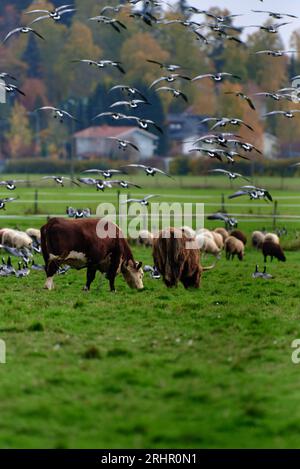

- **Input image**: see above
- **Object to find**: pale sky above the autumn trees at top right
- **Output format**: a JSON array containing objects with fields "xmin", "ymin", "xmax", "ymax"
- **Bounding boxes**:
[{"xmin": 167, "ymin": 0, "xmax": 300, "ymax": 47}]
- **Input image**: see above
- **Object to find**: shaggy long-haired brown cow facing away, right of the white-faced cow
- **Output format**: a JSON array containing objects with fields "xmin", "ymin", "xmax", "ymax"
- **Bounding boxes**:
[{"xmin": 153, "ymin": 228, "xmax": 214, "ymax": 288}]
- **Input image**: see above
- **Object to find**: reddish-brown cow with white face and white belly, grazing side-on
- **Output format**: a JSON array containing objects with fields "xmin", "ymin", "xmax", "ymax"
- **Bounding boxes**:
[{"xmin": 41, "ymin": 218, "xmax": 144, "ymax": 291}]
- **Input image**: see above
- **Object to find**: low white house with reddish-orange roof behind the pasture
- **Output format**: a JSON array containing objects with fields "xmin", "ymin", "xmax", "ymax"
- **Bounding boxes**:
[{"xmin": 74, "ymin": 125, "xmax": 159, "ymax": 160}]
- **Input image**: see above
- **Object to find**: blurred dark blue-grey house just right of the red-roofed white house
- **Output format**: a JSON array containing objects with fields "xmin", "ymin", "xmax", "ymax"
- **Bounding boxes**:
[{"xmin": 167, "ymin": 112, "xmax": 208, "ymax": 156}]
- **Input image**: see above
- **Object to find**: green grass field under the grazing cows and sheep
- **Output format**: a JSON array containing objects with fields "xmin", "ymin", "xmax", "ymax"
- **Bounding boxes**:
[{"xmin": 0, "ymin": 177, "xmax": 300, "ymax": 448}]
